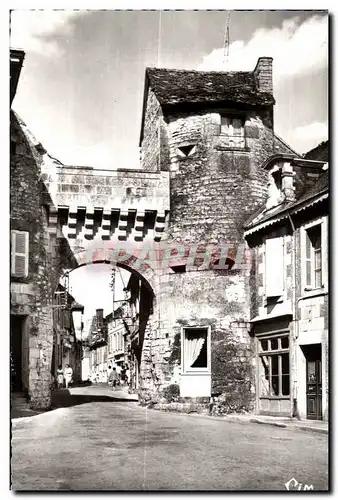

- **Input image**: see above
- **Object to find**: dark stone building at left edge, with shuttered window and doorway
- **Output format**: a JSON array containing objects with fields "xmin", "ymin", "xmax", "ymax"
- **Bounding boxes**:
[{"xmin": 10, "ymin": 50, "xmax": 74, "ymax": 409}]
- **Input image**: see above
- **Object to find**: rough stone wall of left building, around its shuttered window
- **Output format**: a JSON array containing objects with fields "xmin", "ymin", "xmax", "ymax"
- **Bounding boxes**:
[{"xmin": 10, "ymin": 113, "xmax": 74, "ymax": 409}]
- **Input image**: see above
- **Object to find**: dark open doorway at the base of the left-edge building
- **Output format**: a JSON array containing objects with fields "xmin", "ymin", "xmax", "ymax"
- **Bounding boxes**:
[{"xmin": 10, "ymin": 314, "xmax": 25, "ymax": 392}]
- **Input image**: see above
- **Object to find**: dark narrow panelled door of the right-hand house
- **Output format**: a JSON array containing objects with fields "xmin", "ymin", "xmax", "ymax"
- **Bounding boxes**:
[{"xmin": 306, "ymin": 344, "xmax": 323, "ymax": 420}]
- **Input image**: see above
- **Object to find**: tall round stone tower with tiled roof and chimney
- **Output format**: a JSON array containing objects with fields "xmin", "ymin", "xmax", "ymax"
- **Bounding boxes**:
[{"xmin": 140, "ymin": 57, "xmax": 294, "ymax": 408}]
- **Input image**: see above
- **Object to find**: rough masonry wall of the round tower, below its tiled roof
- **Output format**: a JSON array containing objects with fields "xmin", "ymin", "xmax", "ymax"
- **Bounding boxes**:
[{"xmin": 137, "ymin": 93, "xmax": 273, "ymax": 412}]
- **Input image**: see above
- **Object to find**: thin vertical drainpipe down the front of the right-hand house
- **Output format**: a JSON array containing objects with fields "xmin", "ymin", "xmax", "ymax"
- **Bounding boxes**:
[{"xmin": 287, "ymin": 212, "xmax": 300, "ymax": 420}]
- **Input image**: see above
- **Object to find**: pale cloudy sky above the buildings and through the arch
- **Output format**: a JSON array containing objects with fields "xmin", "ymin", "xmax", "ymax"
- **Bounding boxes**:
[{"xmin": 11, "ymin": 10, "xmax": 328, "ymax": 324}]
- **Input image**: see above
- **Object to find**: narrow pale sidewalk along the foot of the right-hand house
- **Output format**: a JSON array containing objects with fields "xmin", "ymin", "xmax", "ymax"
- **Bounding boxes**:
[{"xmin": 223, "ymin": 415, "xmax": 329, "ymax": 434}]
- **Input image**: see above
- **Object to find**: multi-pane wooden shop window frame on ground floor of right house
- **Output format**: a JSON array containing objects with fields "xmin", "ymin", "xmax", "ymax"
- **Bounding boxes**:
[{"xmin": 256, "ymin": 330, "xmax": 292, "ymax": 399}]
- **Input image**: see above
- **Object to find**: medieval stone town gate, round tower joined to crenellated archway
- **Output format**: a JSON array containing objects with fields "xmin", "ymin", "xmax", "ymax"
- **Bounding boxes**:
[{"xmin": 36, "ymin": 58, "xmax": 284, "ymax": 408}]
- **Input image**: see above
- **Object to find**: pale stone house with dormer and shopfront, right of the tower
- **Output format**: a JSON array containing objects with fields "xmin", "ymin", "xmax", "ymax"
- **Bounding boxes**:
[{"xmin": 245, "ymin": 143, "xmax": 329, "ymax": 420}]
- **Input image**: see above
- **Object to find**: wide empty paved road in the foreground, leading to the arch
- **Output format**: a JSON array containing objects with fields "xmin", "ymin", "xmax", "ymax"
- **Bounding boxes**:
[{"xmin": 12, "ymin": 387, "xmax": 328, "ymax": 491}]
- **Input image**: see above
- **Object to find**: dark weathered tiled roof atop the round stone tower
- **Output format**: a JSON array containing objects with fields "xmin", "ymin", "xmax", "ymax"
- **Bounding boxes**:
[{"xmin": 146, "ymin": 68, "xmax": 275, "ymax": 105}]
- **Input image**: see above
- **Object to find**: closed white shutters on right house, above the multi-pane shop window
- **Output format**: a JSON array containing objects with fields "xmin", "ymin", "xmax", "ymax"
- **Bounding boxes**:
[{"xmin": 265, "ymin": 237, "xmax": 284, "ymax": 297}]
